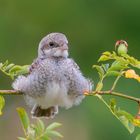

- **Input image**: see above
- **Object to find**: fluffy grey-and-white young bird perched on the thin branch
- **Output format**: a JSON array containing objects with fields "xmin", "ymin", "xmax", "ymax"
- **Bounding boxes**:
[{"xmin": 12, "ymin": 33, "xmax": 92, "ymax": 118}]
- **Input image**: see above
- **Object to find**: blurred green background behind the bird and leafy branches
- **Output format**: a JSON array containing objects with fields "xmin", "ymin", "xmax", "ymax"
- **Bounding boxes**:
[{"xmin": 0, "ymin": 0, "xmax": 140, "ymax": 140}]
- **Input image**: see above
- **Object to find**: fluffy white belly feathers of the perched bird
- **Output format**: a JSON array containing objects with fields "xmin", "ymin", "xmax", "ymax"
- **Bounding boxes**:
[{"xmin": 36, "ymin": 82, "xmax": 74, "ymax": 108}]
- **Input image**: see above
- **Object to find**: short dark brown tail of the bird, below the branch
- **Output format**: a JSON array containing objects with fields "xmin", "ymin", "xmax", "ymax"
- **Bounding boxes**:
[{"xmin": 31, "ymin": 105, "xmax": 58, "ymax": 119}]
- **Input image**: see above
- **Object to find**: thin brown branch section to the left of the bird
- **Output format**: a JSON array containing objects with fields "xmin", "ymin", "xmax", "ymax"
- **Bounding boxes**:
[{"xmin": 0, "ymin": 90, "xmax": 23, "ymax": 95}]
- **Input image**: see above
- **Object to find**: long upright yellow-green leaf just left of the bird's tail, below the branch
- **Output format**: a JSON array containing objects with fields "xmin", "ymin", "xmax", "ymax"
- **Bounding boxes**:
[{"xmin": 17, "ymin": 107, "xmax": 30, "ymax": 133}]
